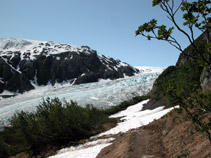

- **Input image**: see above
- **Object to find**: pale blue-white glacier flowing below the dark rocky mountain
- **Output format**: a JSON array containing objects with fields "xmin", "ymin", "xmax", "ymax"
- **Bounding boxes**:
[{"xmin": 0, "ymin": 67, "xmax": 164, "ymax": 128}]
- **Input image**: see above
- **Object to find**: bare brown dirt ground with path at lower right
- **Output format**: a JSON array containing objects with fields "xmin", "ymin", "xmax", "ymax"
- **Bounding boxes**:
[{"xmin": 97, "ymin": 112, "xmax": 211, "ymax": 158}]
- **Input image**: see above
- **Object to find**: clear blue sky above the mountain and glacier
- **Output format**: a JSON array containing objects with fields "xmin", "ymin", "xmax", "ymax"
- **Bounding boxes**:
[{"xmin": 0, "ymin": 0, "xmax": 201, "ymax": 67}]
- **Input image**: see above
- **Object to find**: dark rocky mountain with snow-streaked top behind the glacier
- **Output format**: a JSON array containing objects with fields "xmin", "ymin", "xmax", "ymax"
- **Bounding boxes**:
[{"xmin": 0, "ymin": 38, "xmax": 139, "ymax": 93}]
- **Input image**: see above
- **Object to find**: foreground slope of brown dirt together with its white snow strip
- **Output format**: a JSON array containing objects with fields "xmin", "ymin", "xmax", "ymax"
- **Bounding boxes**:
[{"xmin": 6, "ymin": 100, "xmax": 211, "ymax": 158}]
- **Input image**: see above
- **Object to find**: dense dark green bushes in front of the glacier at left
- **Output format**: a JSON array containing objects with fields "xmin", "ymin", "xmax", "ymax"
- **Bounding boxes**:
[{"xmin": 0, "ymin": 96, "xmax": 148, "ymax": 158}]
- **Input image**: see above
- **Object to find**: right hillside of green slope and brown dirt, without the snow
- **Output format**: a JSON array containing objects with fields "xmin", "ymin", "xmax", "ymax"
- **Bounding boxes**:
[{"xmin": 97, "ymin": 32, "xmax": 211, "ymax": 158}]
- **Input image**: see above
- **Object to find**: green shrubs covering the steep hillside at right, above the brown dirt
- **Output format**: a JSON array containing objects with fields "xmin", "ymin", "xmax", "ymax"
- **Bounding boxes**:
[{"xmin": 149, "ymin": 44, "xmax": 211, "ymax": 141}]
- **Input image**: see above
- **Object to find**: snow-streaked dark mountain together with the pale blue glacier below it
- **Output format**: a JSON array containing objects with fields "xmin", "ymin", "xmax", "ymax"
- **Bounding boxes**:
[{"xmin": 0, "ymin": 38, "xmax": 166, "ymax": 127}]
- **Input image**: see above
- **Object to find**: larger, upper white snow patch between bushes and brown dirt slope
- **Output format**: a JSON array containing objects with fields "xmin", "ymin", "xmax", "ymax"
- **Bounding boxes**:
[{"xmin": 94, "ymin": 100, "xmax": 178, "ymax": 138}]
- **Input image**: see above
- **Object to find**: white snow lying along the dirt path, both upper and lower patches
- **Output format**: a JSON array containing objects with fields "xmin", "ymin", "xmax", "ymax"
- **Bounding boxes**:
[{"xmin": 49, "ymin": 100, "xmax": 177, "ymax": 158}]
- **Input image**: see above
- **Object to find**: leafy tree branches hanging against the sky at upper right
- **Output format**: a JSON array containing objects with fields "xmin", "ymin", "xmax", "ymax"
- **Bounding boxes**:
[{"xmin": 136, "ymin": 0, "xmax": 211, "ymax": 67}]
